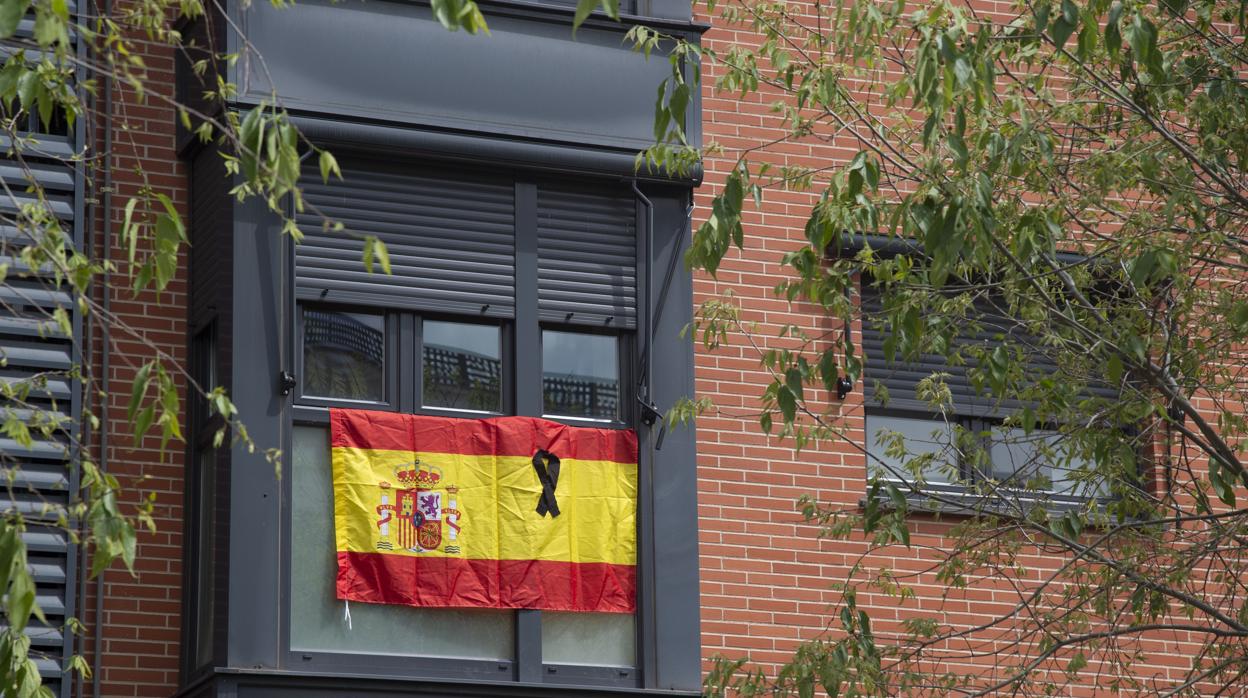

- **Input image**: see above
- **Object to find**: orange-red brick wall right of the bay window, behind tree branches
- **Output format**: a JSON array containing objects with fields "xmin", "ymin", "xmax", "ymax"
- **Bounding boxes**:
[{"xmin": 694, "ymin": 1, "xmax": 1213, "ymax": 694}]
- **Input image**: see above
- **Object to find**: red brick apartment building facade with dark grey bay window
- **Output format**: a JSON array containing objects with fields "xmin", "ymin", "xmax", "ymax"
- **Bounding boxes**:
[{"xmin": 0, "ymin": 0, "xmax": 1208, "ymax": 697}]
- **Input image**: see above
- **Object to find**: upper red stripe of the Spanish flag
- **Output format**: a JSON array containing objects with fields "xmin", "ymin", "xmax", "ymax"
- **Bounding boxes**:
[{"xmin": 329, "ymin": 410, "xmax": 636, "ymax": 463}]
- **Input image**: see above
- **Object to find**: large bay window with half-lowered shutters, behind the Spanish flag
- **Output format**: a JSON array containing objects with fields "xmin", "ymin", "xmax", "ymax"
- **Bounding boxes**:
[{"xmin": 286, "ymin": 157, "xmax": 639, "ymax": 686}]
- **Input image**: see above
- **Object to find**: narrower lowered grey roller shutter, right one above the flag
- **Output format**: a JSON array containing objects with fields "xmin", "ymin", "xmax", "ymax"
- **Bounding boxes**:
[{"xmin": 538, "ymin": 185, "xmax": 636, "ymax": 328}]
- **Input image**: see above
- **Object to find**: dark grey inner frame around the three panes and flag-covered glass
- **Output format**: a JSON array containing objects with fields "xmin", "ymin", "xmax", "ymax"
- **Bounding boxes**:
[{"xmin": 280, "ymin": 158, "xmax": 653, "ymax": 688}]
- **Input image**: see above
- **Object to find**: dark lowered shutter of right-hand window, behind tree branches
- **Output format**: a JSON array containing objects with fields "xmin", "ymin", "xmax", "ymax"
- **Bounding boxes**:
[{"xmin": 861, "ymin": 283, "xmax": 1118, "ymax": 418}]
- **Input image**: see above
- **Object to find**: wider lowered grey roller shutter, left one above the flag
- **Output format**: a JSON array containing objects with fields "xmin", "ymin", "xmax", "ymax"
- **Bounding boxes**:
[{"xmin": 295, "ymin": 161, "xmax": 515, "ymax": 317}]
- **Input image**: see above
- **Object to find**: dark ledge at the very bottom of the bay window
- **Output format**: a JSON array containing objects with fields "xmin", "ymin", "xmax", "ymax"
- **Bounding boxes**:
[{"xmin": 173, "ymin": 668, "xmax": 700, "ymax": 698}]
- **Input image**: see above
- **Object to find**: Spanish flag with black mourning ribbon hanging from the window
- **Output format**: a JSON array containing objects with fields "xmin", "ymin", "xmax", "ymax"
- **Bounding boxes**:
[{"xmin": 326, "ymin": 410, "xmax": 636, "ymax": 613}]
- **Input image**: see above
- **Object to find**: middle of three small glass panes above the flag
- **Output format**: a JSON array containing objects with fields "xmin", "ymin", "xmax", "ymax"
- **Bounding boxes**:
[{"xmin": 423, "ymin": 320, "xmax": 503, "ymax": 412}]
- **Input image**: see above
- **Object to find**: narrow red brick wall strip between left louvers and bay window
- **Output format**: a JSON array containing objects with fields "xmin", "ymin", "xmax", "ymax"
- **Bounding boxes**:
[{"xmin": 79, "ymin": 34, "xmax": 188, "ymax": 697}]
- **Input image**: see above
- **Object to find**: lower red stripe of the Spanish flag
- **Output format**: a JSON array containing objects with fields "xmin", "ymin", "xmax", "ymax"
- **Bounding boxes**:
[{"xmin": 337, "ymin": 552, "xmax": 636, "ymax": 613}]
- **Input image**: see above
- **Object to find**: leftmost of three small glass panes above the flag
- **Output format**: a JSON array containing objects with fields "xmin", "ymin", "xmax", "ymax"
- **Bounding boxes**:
[{"xmin": 303, "ymin": 308, "xmax": 386, "ymax": 402}]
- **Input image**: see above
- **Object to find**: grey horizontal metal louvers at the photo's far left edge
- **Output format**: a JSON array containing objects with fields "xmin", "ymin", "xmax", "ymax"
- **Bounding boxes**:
[{"xmin": 0, "ymin": 134, "xmax": 81, "ymax": 696}]
